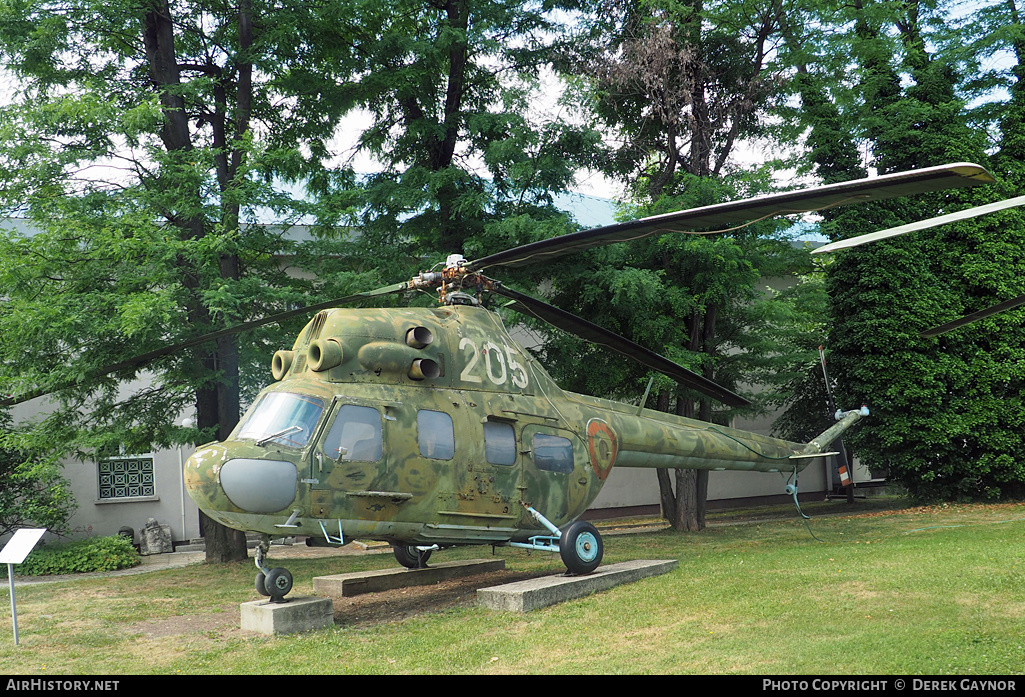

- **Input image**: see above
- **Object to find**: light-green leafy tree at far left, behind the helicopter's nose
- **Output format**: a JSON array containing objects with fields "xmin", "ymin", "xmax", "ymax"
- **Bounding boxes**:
[{"xmin": 0, "ymin": 0, "xmax": 373, "ymax": 561}]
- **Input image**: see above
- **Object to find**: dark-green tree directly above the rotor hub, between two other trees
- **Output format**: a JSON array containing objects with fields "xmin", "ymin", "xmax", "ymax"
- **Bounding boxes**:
[{"xmin": 311, "ymin": 0, "xmax": 599, "ymax": 262}]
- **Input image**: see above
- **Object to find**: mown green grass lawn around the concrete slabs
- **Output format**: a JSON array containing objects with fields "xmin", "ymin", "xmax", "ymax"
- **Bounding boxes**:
[{"xmin": 0, "ymin": 503, "xmax": 1025, "ymax": 675}]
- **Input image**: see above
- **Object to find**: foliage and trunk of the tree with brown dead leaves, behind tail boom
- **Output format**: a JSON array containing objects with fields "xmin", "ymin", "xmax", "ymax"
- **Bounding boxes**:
[{"xmin": 545, "ymin": 0, "xmax": 828, "ymax": 530}]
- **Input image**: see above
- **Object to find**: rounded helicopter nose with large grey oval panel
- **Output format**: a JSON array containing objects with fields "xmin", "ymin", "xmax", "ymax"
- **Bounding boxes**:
[{"xmin": 186, "ymin": 443, "xmax": 298, "ymax": 514}]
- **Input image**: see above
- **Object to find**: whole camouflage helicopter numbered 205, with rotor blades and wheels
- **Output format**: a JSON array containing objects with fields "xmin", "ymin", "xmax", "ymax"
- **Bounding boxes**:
[{"xmin": 172, "ymin": 158, "xmax": 994, "ymax": 602}]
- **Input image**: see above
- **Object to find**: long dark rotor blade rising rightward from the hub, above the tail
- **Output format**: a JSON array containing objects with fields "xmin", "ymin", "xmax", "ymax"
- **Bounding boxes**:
[{"xmin": 466, "ymin": 162, "xmax": 995, "ymax": 271}]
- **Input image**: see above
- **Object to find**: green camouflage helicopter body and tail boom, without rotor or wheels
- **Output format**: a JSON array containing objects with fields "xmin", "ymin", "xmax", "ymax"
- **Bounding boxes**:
[{"xmin": 186, "ymin": 305, "xmax": 831, "ymax": 546}]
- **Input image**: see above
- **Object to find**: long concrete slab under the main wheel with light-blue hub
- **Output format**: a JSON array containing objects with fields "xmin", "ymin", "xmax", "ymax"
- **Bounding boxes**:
[{"xmin": 477, "ymin": 559, "xmax": 679, "ymax": 612}]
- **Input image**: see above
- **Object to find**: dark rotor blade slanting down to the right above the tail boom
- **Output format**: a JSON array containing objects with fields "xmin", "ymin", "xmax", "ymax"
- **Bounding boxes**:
[{"xmin": 492, "ymin": 284, "xmax": 751, "ymax": 407}]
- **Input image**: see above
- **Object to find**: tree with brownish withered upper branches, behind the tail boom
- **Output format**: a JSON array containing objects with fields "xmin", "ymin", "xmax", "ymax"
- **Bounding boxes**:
[{"xmin": 561, "ymin": 0, "xmax": 807, "ymax": 530}]
